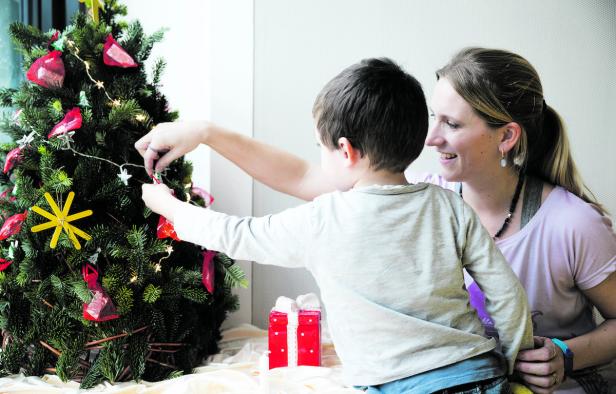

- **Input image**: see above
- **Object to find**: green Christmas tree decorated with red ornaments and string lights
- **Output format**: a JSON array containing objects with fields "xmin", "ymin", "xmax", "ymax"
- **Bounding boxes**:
[{"xmin": 0, "ymin": 0, "xmax": 246, "ymax": 388}]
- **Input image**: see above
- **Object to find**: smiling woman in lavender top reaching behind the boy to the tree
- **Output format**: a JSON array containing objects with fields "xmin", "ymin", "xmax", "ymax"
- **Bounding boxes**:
[{"xmin": 136, "ymin": 48, "xmax": 616, "ymax": 393}]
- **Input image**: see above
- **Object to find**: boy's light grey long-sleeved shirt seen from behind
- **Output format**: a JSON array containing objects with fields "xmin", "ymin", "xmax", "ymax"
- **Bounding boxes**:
[{"xmin": 174, "ymin": 183, "xmax": 533, "ymax": 386}]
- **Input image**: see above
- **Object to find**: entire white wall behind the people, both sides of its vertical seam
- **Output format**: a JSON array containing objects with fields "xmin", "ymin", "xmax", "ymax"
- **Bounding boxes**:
[{"xmin": 119, "ymin": 0, "xmax": 616, "ymax": 327}]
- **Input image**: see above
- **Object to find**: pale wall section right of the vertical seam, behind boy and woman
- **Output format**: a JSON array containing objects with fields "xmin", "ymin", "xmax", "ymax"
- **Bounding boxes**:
[{"xmin": 252, "ymin": 0, "xmax": 616, "ymax": 327}]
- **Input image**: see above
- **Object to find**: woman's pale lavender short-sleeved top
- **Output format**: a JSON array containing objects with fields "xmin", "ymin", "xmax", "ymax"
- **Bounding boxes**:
[{"xmin": 496, "ymin": 187, "xmax": 616, "ymax": 339}]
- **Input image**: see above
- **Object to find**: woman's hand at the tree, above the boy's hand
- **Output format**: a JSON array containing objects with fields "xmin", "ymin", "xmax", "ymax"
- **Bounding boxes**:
[{"xmin": 135, "ymin": 122, "xmax": 209, "ymax": 176}]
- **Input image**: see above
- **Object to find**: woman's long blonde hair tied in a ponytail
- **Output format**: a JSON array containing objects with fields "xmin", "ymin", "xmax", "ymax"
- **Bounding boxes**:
[{"xmin": 436, "ymin": 47, "xmax": 607, "ymax": 215}]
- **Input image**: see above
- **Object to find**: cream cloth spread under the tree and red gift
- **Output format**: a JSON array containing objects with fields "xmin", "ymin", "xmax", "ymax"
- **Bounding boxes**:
[{"xmin": 0, "ymin": 325, "xmax": 361, "ymax": 394}]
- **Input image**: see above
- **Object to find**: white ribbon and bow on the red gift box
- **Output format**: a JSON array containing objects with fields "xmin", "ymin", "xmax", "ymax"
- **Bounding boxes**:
[{"xmin": 273, "ymin": 293, "xmax": 321, "ymax": 367}]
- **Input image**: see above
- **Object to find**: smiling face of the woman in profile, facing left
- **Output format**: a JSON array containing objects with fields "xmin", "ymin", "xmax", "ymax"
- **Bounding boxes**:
[{"xmin": 426, "ymin": 78, "xmax": 501, "ymax": 182}]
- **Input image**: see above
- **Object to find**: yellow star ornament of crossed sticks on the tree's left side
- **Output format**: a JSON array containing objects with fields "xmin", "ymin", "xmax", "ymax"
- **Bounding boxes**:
[{"xmin": 30, "ymin": 192, "xmax": 92, "ymax": 250}]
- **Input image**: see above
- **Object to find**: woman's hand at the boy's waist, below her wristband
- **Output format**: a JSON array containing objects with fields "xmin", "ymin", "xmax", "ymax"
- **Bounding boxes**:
[{"xmin": 515, "ymin": 337, "xmax": 565, "ymax": 394}]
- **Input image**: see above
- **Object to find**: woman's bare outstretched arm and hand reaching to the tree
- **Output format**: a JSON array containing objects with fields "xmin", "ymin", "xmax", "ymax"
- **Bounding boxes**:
[{"xmin": 135, "ymin": 122, "xmax": 335, "ymax": 201}]
